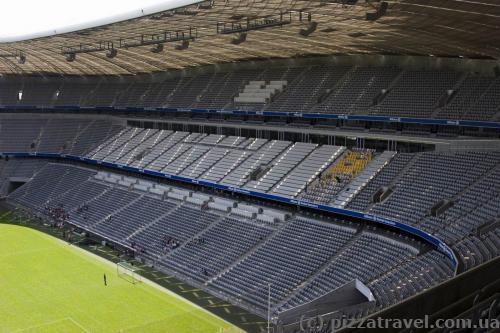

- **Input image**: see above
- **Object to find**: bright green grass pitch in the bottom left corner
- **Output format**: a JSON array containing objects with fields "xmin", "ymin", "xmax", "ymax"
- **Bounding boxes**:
[{"xmin": 0, "ymin": 220, "xmax": 243, "ymax": 333}]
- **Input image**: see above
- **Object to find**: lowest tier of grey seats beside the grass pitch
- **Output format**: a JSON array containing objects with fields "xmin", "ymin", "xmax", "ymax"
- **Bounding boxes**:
[{"xmin": 4, "ymin": 160, "xmax": 452, "ymax": 314}]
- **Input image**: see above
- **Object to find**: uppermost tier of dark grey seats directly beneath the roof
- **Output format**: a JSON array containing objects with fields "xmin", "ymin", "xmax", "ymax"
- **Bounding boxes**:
[{"xmin": 0, "ymin": 64, "xmax": 500, "ymax": 121}]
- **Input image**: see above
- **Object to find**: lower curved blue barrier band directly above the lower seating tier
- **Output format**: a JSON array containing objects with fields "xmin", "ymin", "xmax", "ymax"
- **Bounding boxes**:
[{"xmin": 0, "ymin": 152, "xmax": 458, "ymax": 272}]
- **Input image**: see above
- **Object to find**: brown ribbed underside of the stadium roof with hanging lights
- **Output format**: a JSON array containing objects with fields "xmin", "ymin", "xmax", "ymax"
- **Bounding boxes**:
[{"xmin": 0, "ymin": 0, "xmax": 500, "ymax": 75}]
